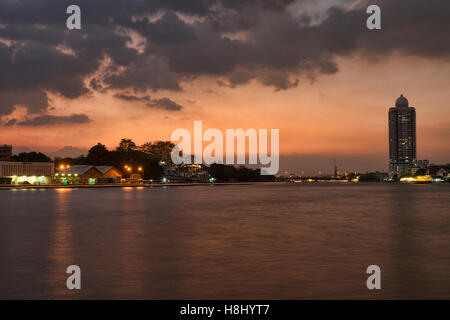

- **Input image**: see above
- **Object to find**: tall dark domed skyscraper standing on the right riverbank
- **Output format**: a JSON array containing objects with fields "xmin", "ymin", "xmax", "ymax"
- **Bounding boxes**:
[{"xmin": 389, "ymin": 95, "xmax": 417, "ymax": 178}]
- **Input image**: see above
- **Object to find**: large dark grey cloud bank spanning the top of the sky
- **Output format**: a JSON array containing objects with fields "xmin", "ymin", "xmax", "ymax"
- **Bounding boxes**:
[{"xmin": 0, "ymin": 0, "xmax": 450, "ymax": 115}]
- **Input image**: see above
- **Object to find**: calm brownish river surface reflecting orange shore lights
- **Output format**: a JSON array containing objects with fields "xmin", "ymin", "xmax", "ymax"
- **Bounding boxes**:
[{"xmin": 0, "ymin": 183, "xmax": 450, "ymax": 299}]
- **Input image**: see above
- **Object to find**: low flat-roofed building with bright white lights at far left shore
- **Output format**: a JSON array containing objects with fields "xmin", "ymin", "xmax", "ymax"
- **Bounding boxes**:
[{"xmin": 0, "ymin": 161, "xmax": 55, "ymax": 185}]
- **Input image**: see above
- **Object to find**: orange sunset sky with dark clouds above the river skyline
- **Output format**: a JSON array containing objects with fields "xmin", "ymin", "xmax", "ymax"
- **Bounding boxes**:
[{"xmin": 0, "ymin": 0, "xmax": 450, "ymax": 173}]
